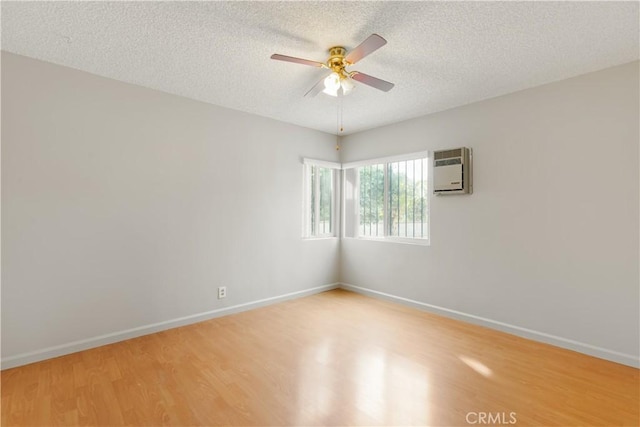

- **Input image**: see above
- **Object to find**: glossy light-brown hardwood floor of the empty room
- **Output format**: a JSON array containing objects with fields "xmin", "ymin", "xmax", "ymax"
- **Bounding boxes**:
[{"xmin": 1, "ymin": 290, "xmax": 640, "ymax": 426}]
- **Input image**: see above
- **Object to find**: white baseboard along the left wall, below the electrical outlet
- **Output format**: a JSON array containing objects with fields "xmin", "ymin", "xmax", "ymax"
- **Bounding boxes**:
[{"xmin": 0, "ymin": 283, "xmax": 340, "ymax": 369}]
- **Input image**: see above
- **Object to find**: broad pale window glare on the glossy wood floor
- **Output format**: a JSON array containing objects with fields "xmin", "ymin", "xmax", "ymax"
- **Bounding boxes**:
[{"xmin": 296, "ymin": 338, "xmax": 433, "ymax": 425}]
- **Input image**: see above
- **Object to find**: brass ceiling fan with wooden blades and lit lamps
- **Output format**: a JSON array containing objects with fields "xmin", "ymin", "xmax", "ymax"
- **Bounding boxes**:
[{"xmin": 271, "ymin": 34, "xmax": 394, "ymax": 96}]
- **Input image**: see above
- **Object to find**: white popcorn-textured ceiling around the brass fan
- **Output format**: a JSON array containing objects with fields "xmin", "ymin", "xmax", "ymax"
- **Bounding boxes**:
[{"xmin": 1, "ymin": 1, "xmax": 639, "ymax": 134}]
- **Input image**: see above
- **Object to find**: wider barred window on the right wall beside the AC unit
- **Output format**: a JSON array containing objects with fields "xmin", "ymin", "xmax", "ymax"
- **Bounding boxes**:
[{"xmin": 345, "ymin": 153, "xmax": 429, "ymax": 243}]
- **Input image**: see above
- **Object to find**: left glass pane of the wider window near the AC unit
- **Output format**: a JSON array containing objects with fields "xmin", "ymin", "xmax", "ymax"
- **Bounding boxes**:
[{"xmin": 358, "ymin": 164, "xmax": 384, "ymax": 237}]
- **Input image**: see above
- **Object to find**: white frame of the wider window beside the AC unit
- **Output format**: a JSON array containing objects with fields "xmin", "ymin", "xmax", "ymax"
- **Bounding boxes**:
[{"xmin": 342, "ymin": 151, "xmax": 433, "ymax": 246}]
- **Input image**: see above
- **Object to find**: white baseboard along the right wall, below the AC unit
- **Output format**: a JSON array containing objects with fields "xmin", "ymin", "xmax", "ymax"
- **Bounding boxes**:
[{"xmin": 340, "ymin": 283, "xmax": 640, "ymax": 368}]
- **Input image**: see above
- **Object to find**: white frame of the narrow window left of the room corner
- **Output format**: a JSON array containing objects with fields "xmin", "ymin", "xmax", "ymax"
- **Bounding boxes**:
[{"xmin": 302, "ymin": 158, "xmax": 342, "ymax": 240}]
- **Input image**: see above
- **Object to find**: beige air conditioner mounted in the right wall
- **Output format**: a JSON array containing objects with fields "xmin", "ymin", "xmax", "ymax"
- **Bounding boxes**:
[{"xmin": 433, "ymin": 147, "xmax": 473, "ymax": 195}]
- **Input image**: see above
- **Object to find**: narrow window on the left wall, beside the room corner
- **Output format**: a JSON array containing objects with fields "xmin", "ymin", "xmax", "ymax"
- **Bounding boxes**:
[{"xmin": 303, "ymin": 159, "xmax": 340, "ymax": 237}]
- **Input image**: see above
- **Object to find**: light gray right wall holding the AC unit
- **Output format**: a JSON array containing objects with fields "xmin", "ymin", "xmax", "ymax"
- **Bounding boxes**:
[{"xmin": 341, "ymin": 62, "xmax": 640, "ymax": 365}]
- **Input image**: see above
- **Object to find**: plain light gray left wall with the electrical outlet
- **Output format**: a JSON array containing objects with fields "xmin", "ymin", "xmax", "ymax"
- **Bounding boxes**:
[{"xmin": 2, "ymin": 52, "xmax": 339, "ymax": 367}]
